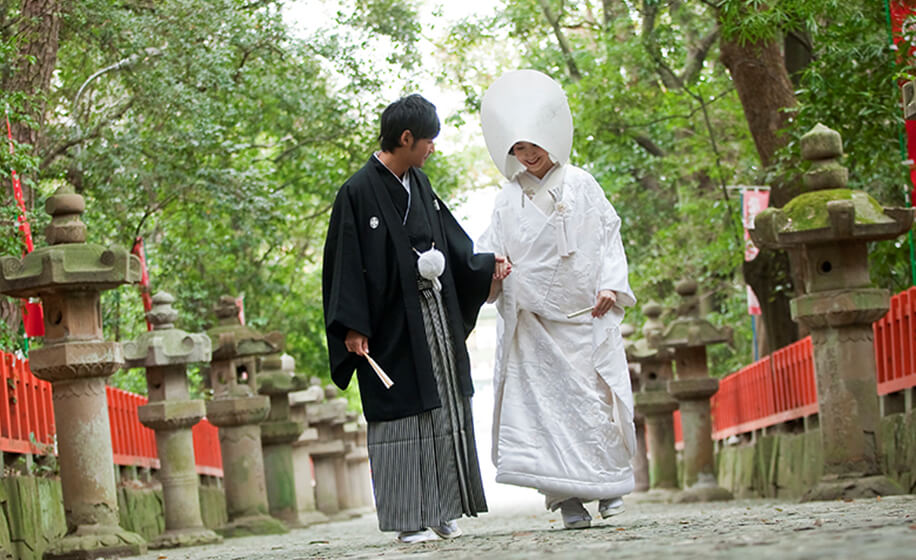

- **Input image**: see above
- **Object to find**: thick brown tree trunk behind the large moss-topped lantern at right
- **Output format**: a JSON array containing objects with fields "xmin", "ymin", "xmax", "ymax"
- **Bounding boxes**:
[{"xmin": 720, "ymin": 30, "xmax": 800, "ymax": 353}]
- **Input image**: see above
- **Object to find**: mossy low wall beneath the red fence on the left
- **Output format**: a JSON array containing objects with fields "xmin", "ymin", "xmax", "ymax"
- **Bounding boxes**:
[{"xmin": 0, "ymin": 476, "xmax": 227, "ymax": 560}]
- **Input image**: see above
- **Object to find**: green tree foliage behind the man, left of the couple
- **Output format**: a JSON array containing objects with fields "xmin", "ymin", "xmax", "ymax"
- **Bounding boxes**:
[{"xmin": 0, "ymin": 0, "xmax": 454, "ymax": 390}]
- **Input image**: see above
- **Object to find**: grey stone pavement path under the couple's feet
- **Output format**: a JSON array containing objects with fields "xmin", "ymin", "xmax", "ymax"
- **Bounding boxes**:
[{"xmin": 137, "ymin": 495, "xmax": 916, "ymax": 560}]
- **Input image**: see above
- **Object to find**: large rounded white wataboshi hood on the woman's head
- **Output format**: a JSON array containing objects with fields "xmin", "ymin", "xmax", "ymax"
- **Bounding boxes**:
[{"xmin": 480, "ymin": 70, "xmax": 573, "ymax": 179}]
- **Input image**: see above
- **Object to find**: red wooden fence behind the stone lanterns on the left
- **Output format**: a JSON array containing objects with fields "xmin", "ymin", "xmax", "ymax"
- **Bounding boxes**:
[{"xmin": 0, "ymin": 352, "xmax": 223, "ymax": 477}]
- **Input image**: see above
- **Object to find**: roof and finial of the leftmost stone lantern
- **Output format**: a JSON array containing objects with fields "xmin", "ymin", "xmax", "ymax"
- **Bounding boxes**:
[{"xmin": 0, "ymin": 186, "xmax": 140, "ymax": 298}]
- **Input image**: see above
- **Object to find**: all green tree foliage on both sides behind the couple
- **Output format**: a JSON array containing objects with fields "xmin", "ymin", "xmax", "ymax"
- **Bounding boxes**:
[{"xmin": 0, "ymin": 0, "xmax": 909, "ymax": 390}]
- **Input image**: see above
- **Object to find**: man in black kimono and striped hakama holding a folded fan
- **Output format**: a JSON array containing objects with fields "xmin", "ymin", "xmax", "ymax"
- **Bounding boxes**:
[{"xmin": 322, "ymin": 94, "xmax": 509, "ymax": 542}]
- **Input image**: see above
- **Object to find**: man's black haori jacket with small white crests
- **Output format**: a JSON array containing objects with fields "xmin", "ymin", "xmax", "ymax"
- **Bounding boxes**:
[{"xmin": 322, "ymin": 157, "xmax": 495, "ymax": 422}]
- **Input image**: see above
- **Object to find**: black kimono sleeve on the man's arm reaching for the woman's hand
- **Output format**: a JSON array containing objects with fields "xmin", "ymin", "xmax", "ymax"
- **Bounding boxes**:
[{"xmin": 438, "ymin": 200, "xmax": 496, "ymax": 338}]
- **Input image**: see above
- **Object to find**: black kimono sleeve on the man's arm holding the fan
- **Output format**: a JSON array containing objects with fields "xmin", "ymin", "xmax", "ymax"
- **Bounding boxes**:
[{"xmin": 321, "ymin": 185, "xmax": 373, "ymax": 389}]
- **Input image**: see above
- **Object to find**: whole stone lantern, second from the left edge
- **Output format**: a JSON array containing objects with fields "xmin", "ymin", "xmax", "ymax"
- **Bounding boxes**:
[{"xmin": 124, "ymin": 292, "xmax": 222, "ymax": 548}]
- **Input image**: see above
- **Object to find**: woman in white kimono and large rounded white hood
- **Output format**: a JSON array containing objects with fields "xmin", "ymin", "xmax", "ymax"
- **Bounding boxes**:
[{"xmin": 477, "ymin": 70, "xmax": 636, "ymax": 528}]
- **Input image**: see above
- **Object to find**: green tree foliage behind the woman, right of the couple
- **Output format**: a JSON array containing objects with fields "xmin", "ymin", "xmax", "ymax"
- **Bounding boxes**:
[{"xmin": 441, "ymin": 0, "xmax": 908, "ymax": 373}]
